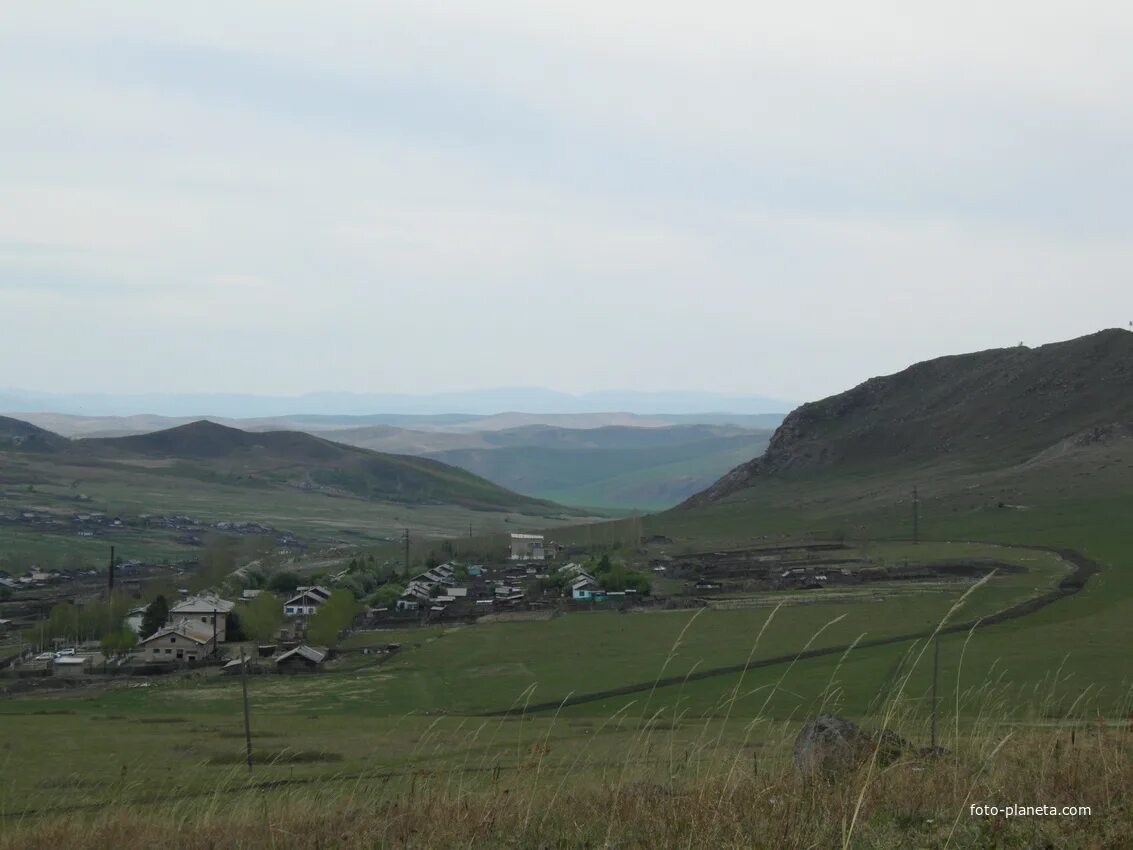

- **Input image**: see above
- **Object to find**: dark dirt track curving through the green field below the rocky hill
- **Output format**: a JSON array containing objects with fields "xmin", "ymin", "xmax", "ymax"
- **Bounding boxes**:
[{"xmin": 477, "ymin": 541, "xmax": 1101, "ymax": 717}]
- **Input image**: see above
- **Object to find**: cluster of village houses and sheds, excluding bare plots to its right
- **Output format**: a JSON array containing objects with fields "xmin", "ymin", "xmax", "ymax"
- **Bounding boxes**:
[{"xmin": 0, "ymin": 534, "xmax": 648, "ymax": 680}]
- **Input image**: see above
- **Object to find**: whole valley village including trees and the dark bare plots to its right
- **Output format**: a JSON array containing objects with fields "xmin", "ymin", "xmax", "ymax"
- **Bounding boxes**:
[{"xmin": 0, "ymin": 534, "xmax": 1001, "ymax": 681}]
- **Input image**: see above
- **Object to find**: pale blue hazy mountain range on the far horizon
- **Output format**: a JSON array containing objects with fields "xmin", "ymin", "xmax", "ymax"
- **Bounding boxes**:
[{"xmin": 0, "ymin": 388, "xmax": 791, "ymax": 424}]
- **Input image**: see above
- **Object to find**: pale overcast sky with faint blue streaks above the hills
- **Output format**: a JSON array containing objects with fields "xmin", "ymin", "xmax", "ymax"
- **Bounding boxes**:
[{"xmin": 0, "ymin": 0, "xmax": 1133, "ymax": 400}]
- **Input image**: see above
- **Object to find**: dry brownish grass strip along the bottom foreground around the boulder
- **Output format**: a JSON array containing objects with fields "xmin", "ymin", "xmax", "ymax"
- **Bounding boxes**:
[{"xmin": 0, "ymin": 722, "xmax": 1133, "ymax": 850}]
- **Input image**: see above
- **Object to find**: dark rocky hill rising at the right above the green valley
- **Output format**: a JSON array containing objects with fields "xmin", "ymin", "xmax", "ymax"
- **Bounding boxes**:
[{"xmin": 682, "ymin": 329, "xmax": 1133, "ymax": 508}]
